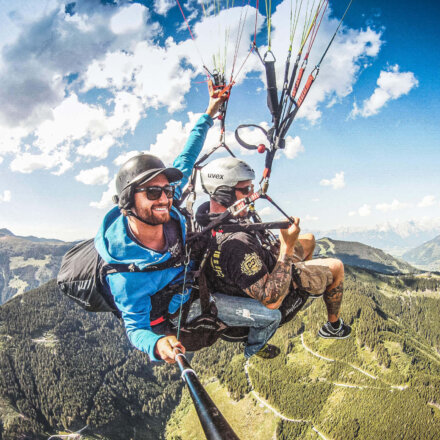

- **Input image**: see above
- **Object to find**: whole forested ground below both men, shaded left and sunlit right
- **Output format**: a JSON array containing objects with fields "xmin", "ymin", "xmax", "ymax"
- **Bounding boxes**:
[{"xmin": 0, "ymin": 267, "xmax": 440, "ymax": 440}]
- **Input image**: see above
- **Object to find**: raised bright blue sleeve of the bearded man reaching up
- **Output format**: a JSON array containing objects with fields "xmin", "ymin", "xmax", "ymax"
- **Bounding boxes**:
[{"xmin": 173, "ymin": 113, "xmax": 214, "ymax": 199}]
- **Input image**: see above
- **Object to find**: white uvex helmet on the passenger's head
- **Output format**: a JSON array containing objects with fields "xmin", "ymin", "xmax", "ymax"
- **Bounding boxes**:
[{"xmin": 200, "ymin": 157, "xmax": 255, "ymax": 206}]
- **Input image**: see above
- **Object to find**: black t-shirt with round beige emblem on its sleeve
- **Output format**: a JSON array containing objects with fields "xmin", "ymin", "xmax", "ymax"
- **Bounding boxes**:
[{"xmin": 206, "ymin": 232, "xmax": 276, "ymax": 297}]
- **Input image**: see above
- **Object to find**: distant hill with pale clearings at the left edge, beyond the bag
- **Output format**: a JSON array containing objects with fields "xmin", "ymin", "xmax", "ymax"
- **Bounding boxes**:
[{"xmin": 0, "ymin": 229, "xmax": 73, "ymax": 304}]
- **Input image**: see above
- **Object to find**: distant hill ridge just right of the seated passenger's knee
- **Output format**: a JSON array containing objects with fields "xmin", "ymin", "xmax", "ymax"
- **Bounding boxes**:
[{"xmin": 314, "ymin": 237, "xmax": 420, "ymax": 274}]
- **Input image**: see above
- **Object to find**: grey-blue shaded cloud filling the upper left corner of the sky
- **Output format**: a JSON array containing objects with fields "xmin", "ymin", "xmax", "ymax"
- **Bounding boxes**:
[{"xmin": 0, "ymin": 0, "xmax": 158, "ymax": 127}]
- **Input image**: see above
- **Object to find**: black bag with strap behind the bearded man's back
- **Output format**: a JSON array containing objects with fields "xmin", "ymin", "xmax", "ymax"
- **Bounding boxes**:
[{"xmin": 57, "ymin": 239, "xmax": 183, "ymax": 318}]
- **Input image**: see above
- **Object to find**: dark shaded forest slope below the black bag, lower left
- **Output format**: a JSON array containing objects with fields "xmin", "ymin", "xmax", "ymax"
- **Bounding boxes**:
[{"xmin": 0, "ymin": 281, "xmax": 182, "ymax": 440}]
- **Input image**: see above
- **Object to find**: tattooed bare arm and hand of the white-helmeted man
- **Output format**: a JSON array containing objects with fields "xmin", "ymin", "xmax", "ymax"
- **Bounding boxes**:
[{"xmin": 245, "ymin": 218, "xmax": 300, "ymax": 309}]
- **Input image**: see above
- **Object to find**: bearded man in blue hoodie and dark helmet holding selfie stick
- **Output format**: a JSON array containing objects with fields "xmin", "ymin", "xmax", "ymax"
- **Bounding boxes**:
[{"xmin": 95, "ymin": 91, "xmax": 224, "ymax": 363}]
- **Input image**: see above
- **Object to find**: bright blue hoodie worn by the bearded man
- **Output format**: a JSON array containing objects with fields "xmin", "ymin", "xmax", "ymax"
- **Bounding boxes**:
[{"xmin": 95, "ymin": 114, "xmax": 213, "ymax": 361}]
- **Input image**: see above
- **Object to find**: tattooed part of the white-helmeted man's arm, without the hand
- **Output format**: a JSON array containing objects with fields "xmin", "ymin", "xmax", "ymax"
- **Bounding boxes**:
[{"xmin": 245, "ymin": 255, "xmax": 292, "ymax": 306}]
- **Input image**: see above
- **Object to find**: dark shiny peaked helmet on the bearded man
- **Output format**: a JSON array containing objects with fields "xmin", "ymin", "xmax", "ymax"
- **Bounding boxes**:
[{"xmin": 113, "ymin": 153, "xmax": 183, "ymax": 209}]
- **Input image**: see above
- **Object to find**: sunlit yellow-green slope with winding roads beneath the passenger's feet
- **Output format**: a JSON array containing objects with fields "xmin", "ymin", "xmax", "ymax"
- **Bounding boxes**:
[{"xmin": 167, "ymin": 267, "xmax": 440, "ymax": 440}]
